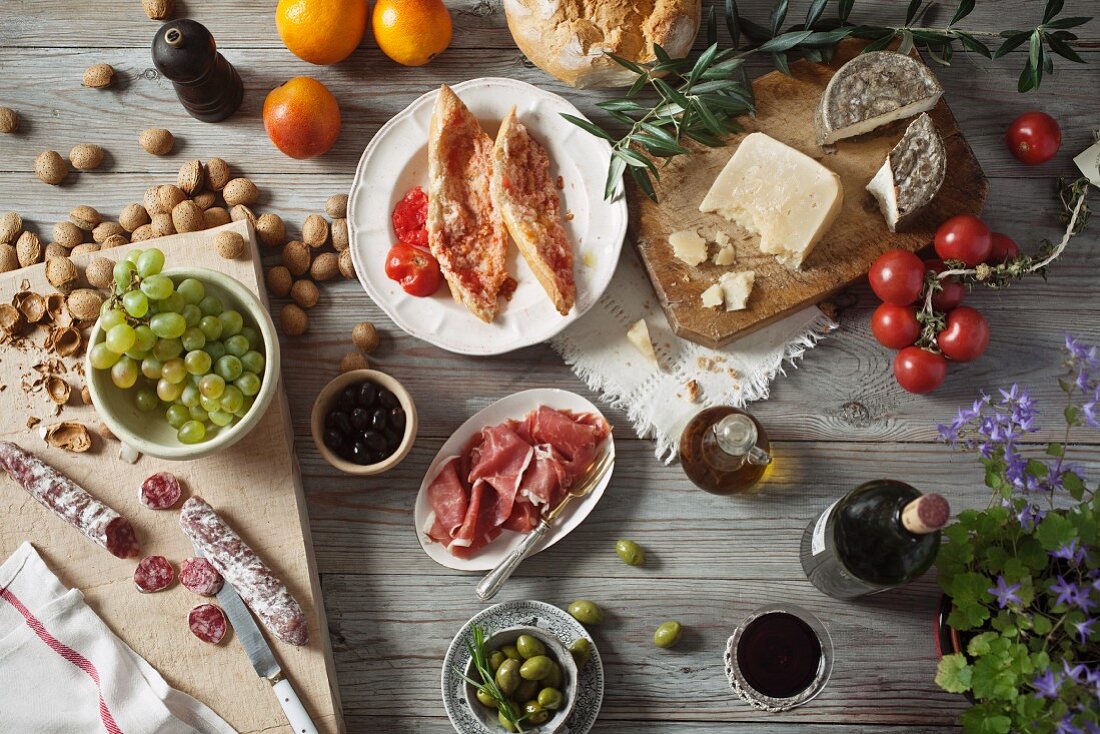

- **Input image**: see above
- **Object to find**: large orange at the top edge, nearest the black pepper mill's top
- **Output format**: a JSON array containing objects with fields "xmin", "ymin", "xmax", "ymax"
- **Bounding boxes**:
[{"xmin": 275, "ymin": 0, "xmax": 369, "ymax": 64}]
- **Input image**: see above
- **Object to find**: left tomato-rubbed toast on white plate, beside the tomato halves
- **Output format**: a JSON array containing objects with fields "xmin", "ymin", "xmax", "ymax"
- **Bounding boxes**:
[{"xmin": 428, "ymin": 85, "xmax": 508, "ymax": 324}]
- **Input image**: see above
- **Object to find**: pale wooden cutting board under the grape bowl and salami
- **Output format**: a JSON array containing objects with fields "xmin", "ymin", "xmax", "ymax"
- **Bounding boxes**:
[{"xmin": 0, "ymin": 222, "xmax": 343, "ymax": 734}]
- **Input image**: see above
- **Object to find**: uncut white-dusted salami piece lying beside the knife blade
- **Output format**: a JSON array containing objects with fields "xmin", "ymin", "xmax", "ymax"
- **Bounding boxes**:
[{"xmin": 179, "ymin": 496, "xmax": 308, "ymax": 645}]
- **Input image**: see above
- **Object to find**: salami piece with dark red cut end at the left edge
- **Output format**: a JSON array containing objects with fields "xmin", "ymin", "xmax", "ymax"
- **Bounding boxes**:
[{"xmin": 0, "ymin": 441, "xmax": 141, "ymax": 558}]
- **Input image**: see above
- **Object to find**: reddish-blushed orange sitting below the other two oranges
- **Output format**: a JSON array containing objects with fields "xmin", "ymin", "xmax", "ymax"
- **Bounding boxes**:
[{"xmin": 264, "ymin": 76, "xmax": 340, "ymax": 158}]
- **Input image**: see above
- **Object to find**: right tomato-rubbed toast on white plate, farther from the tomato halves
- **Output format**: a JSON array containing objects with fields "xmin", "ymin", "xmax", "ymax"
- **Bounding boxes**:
[{"xmin": 493, "ymin": 108, "xmax": 576, "ymax": 316}]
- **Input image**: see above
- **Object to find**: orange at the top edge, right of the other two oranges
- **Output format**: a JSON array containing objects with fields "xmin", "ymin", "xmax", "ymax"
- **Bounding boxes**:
[{"xmin": 372, "ymin": 0, "xmax": 451, "ymax": 66}]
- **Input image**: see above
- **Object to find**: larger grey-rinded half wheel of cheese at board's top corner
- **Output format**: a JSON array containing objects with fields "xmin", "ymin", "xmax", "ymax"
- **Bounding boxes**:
[{"xmin": 814, "ymin": 51, "xmax": 944, "ymax": 145}]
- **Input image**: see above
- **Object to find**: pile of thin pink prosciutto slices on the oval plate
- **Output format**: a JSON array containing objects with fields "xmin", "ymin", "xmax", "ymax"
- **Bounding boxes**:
[{"xmin": 421, "ymin": 406, "xmax": 612, "ymax": 558}]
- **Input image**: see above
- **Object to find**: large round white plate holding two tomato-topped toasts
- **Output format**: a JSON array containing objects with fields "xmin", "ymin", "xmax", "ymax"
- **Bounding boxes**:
[{"xmin": 348, "ymin": 78, "xmax": 627, "ymax": 354}]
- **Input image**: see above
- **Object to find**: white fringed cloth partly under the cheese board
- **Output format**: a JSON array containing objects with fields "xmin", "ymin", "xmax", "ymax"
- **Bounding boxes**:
[{"xmin": 550, "ymin": 247, "xmax": 836, "ymax": 462}]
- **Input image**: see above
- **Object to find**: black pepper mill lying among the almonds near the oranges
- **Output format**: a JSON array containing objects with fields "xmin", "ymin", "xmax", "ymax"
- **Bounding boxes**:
[{"xmin": 153, "ymin": 19, "xmax": 244, "ymax": 122}]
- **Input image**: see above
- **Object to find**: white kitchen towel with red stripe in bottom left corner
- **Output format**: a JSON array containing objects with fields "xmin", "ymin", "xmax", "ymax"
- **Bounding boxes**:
[{"xmin": 0, "ymin": 543, "xmax": 234, "ymax": 734}]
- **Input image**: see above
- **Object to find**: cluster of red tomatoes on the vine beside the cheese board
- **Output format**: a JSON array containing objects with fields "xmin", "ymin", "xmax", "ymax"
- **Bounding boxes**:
[{"xmin": 868, "ymin": 215, "xmax": 1020, "ymax": 393}]
